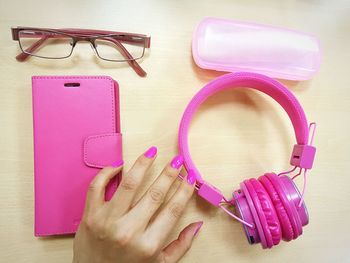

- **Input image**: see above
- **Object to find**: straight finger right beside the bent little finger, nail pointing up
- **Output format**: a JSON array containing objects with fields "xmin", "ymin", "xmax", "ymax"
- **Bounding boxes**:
[{"xmin": 110, "ymin": 146, "xmax": 157, "ymax": 215}]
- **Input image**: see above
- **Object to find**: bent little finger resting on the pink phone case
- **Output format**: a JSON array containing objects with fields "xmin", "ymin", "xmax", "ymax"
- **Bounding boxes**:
[{"xmin": 85, "ymin": 166, "xmax": 123, "ymax": 216}]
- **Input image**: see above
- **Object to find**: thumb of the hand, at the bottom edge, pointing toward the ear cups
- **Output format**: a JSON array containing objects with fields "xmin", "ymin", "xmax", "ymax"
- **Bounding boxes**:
[{"xmin": 159, "ymin": 221, "xmax": 203, "ymax": 263}]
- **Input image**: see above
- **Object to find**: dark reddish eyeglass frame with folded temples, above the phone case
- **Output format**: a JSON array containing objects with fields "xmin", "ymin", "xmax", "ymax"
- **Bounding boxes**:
[{"xmin": 11, "ymin": 27, "xmax": 151, "ymax": 77}]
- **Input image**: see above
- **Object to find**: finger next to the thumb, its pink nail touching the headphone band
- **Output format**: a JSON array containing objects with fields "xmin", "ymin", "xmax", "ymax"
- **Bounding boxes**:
[{"xmin": 145, "ymin": 171, "xmax": 195, "ymax": 244}]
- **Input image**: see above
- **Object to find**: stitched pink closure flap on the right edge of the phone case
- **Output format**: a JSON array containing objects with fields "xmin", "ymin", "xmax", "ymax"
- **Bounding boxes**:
[{"xmin": 84, "ymin": 133, "xmax": 123, "ymax": 168}]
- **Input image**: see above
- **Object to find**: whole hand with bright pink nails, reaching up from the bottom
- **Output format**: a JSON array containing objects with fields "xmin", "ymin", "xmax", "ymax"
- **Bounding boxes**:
[{"xmin": 73, "ymin": 147, "xmax": 203, "ymax": 263}]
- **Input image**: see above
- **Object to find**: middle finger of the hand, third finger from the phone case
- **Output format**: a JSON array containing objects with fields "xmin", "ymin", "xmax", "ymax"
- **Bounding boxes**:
[{"xmin": 128, "ymin": 155, "xmax": 183, "ymax": 228}]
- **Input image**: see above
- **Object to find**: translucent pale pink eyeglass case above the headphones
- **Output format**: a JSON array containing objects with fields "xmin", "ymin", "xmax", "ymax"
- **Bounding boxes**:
[{"xmin": 192, "ymin": 17, "xmax": 321, "ymax": 80}]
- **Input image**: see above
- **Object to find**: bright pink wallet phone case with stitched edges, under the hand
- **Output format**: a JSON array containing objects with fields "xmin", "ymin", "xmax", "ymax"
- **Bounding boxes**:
[{"xmin": 32, "ymin": 76, "xmax": 122, "ymax": 236}]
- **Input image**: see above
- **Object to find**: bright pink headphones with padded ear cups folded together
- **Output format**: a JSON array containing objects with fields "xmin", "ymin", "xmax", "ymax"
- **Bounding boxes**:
[{"xmin": 178, "ymin": 72, "xmax": 316, "ymax": 248}]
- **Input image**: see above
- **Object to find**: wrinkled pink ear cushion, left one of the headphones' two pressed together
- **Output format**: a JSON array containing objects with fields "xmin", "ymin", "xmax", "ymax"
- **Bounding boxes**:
[{"xmin": 250, "ymin": 178, "xmax": 282, "ymax": 248}]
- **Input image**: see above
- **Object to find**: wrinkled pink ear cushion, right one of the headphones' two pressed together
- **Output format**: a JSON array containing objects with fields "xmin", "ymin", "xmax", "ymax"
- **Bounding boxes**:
[{"xmin": 259, "ymin": 175, "xmax": 294, "ymax": 241}]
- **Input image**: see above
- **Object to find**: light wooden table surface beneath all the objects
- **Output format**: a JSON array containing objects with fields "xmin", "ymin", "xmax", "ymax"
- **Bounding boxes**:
[{"xmin": 0, "ymin": 0, "xmax": 350, "ymax": 263}]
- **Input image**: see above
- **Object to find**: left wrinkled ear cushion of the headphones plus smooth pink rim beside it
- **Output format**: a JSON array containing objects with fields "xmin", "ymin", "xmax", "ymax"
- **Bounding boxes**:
[{"xmin": 244, "ymin": 178, "xmax": 282, "ymax": 248}]
